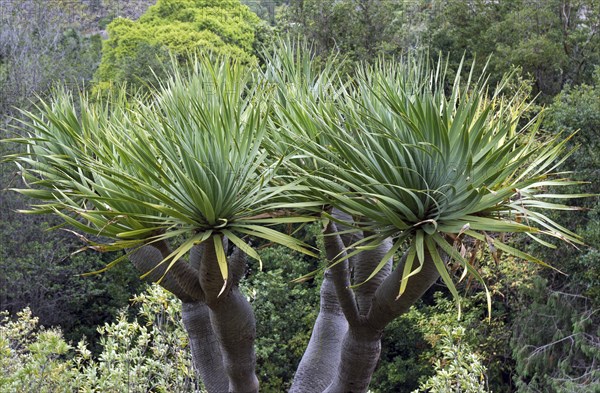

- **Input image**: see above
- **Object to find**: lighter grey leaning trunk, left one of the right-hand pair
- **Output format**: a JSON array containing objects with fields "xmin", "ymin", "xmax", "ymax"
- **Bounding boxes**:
[{"xmin": 290, "ymin": 271, "xmax": 348, "ymax": 393}]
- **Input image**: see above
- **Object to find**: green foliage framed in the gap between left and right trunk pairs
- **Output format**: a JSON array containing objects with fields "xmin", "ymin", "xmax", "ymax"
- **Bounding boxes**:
[{"xmin": 243, "ymin": 247, "xmax": 319, "ymax": 392}]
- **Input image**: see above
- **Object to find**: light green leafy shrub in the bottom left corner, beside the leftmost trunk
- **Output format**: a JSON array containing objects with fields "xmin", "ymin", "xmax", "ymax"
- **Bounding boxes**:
[{"xmin": 0, "ymin": 286, "xmax": 200, "ymax": 393}]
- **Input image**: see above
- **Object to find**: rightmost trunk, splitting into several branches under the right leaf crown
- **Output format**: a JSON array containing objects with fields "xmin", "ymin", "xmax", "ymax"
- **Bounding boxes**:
[{"xmin": 324, "ymin": 223, "xmax": 439, "ymax": 393}]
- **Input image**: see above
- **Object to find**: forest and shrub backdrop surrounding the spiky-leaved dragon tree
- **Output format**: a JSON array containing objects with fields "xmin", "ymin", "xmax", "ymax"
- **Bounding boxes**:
[{"xmin": 0, "ymin": 0, "xmax": 600, "ymax": 392}]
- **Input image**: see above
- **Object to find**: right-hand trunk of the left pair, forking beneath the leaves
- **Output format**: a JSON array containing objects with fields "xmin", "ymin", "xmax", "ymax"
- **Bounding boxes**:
[{"xmin": 199, "ymin": 242, "xmax": 258, "ymax": 393}]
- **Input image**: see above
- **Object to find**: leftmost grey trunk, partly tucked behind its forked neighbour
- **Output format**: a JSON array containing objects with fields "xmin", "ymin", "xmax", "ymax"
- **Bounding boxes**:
[{"xmin": 181, "ymin": 302, "xmax": 229, "ymax": 393}]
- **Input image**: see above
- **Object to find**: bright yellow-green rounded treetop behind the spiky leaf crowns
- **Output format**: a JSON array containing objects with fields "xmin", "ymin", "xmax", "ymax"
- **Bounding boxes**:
[{"xmin": 95, "ymin": 0, "xmax": 262, "ymax": 92}]
